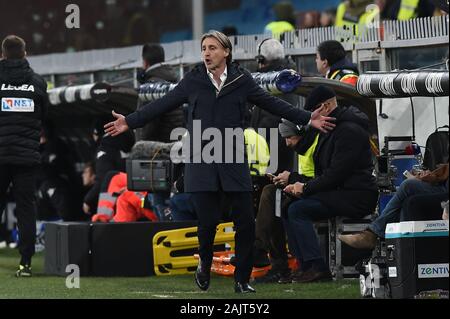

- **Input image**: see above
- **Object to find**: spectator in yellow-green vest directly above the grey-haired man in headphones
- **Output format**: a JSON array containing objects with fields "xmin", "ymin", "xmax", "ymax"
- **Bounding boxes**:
[{"xmin": 264, "ymin": 1, "xmax": 296, "ymax": 39}]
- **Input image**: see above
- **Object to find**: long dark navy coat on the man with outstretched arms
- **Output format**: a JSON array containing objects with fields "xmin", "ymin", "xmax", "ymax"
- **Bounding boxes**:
[{"xmin": 126, "ymin": 63, "xmax": 311, "ymax": 192}]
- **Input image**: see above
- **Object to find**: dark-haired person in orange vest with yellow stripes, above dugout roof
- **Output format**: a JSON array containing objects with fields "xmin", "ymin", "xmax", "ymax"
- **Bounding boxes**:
[{"xmin": 316, "ymin": 40, "xmax": 359, "ymax": 85}]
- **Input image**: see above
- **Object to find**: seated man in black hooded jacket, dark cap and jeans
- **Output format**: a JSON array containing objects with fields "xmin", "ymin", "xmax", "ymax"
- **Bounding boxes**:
[{"xmin": 284, "ymin": 86, "xmax": 378, "ymax": 283}]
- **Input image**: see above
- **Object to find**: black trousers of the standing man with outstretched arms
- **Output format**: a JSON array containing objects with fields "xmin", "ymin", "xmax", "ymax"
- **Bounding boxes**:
[{"xmin": 192, "ymin": 192, "xmax": 255, "ymax": 283}]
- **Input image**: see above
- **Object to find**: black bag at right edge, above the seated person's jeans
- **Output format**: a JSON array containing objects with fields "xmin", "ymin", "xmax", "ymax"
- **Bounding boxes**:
[{"xmin": 423, "ymin": 125, "xmax": 449, "ymax": 171}]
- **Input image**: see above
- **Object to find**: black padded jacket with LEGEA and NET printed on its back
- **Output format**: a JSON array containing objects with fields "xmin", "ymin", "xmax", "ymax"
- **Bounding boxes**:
[{"xmin": 0, "ymin": 59, "xmax": 48, "ymax": 166}]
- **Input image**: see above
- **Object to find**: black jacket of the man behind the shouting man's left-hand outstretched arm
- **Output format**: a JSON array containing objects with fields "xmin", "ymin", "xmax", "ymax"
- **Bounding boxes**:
[{"xmin": 138, "ymin": 64, "xmax": 185, "ymax": 143}]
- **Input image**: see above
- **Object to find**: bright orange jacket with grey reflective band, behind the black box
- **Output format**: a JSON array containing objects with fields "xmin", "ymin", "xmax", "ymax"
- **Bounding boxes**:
[{"xmin": 92, "ymin": 171, "xmax": 158, "ymax": 223}]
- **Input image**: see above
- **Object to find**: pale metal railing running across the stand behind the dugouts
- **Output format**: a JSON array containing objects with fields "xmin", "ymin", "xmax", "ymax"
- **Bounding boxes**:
[{"xmin": 29, "ymin": 16, "xmax": 449, "ymax": 75}]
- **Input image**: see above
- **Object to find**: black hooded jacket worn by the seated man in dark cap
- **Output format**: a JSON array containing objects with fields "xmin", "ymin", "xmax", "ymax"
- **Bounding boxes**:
[{"xmin": 304, "ymin": 106, "xmax": 378, "ymax": 216}]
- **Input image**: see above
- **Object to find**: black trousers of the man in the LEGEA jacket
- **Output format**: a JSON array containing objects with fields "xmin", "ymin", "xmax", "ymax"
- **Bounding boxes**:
[{"xmin": 0, "ymin": 164, "xmax": 36, "ymax": 265}]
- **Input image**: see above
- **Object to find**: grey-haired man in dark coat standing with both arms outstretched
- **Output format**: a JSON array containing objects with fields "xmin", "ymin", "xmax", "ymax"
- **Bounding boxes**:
[{"xmin": 105, "ymin": 31, "xmax": 334, "ymax": 293}]
